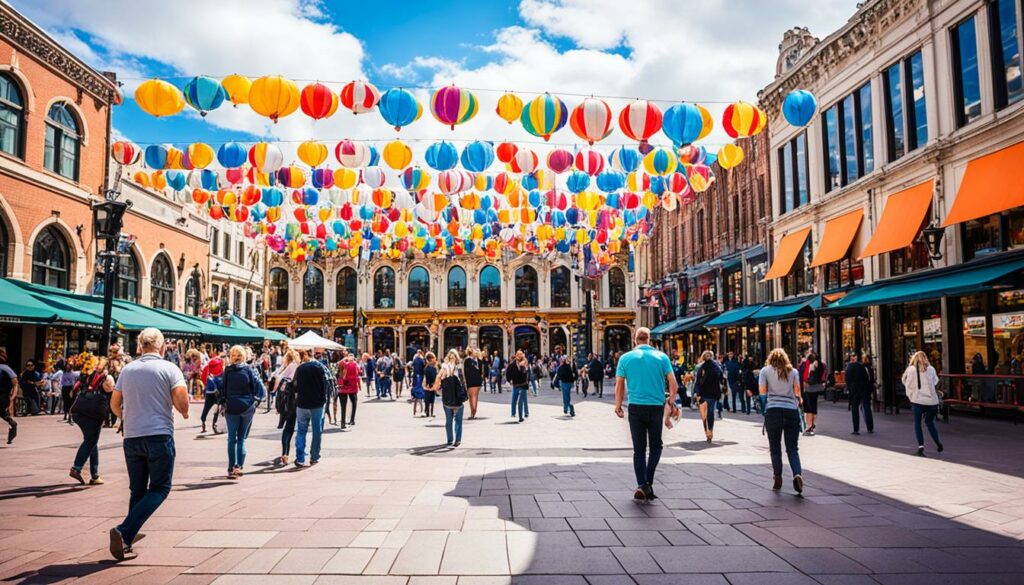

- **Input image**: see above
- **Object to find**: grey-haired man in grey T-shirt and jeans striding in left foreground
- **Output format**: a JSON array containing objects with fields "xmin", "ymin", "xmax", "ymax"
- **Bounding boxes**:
[{"xmin": 110, "ymin": 327, "xmax": 188, "ymax": 560}]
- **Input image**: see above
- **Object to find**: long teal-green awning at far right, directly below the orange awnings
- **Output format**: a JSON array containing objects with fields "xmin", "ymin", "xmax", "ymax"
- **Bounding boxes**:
[{"xmin": 824, "ymin": 255, "xmax": 1024, "ymax": 311}]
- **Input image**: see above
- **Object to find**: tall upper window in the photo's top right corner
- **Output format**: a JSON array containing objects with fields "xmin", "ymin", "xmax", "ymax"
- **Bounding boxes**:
[{"xmin": 988, "ymin": 0, "xmax": 1024, "ymax": 110}]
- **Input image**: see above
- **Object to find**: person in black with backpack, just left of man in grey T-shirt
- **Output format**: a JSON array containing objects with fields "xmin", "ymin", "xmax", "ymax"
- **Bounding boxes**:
[{"xmin": 68, "ymin": 358, "xmax": 114, "ymax": 486}]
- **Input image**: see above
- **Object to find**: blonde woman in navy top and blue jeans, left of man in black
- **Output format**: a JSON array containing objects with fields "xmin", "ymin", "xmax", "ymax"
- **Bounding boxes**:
[{"xmin": 217, "ymin": 345, "xmax": 263, "ymax": 479}]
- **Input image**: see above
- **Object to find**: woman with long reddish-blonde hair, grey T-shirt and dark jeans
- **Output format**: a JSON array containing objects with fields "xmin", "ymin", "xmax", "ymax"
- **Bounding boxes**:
[{"xmin": 758, "ymin": 348, "xmax": 804, "ymax": 494}]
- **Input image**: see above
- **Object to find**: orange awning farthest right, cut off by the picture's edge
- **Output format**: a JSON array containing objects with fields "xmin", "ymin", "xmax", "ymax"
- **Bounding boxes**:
[{"xmin": 942, "ymin": 142, "xmax": 1024, "ymax": 227}]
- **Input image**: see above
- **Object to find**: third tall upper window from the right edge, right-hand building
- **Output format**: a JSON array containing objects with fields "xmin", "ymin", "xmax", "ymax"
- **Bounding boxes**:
[{"xmin": 882, "ymin": 51, "xmax": 928, "ymax": 162}]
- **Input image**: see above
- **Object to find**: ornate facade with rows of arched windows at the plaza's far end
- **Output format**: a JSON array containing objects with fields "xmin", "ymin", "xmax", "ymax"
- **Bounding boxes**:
[{"xmin": 264, "ymin": 257, "xmax": 637, "ymax": 357}]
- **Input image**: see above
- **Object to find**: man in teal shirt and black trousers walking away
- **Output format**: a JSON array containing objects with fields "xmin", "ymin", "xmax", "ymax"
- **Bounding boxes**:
[{"xmin": 615, "ymin": 327, "xmax": 679, "ymax": 502}]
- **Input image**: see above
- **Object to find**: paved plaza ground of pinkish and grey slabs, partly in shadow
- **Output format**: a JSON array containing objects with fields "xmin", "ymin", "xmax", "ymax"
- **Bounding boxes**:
[{"xmin": 0, "ymin": 390, "xmax": 1024, "ymax": 585}]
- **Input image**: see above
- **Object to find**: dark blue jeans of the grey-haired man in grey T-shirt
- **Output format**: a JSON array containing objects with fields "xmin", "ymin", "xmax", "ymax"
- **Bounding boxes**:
[{"xmin": 118, "ymin": 434, "xmax": 175, "ymax": 545}]
